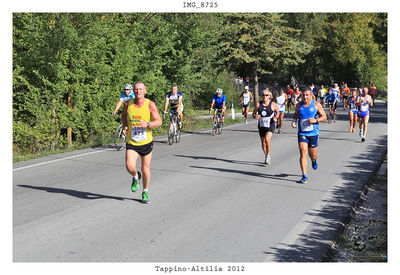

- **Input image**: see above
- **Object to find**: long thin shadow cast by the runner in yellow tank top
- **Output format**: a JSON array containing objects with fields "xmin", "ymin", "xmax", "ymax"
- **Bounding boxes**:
[{"xmin": 17, "ymin": 184, "xmax": 142, "ymax": 203}]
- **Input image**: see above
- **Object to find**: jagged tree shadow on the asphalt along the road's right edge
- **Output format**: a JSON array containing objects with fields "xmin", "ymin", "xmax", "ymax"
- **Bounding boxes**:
[{"xmin": 264, "ymin": 136, "xmax": 387, "ymax": 262}]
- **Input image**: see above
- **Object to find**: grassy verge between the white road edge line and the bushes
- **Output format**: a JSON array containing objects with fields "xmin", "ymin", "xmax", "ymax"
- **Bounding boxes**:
[{"xmin": 13, "ymin": 110, "xmax": 243, "ymax": 163}]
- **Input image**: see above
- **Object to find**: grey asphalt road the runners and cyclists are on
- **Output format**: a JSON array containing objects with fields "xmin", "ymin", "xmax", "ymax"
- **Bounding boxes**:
[{"xmin": 13, "ymin": 102, "xmax": 387, "ymax": 262}]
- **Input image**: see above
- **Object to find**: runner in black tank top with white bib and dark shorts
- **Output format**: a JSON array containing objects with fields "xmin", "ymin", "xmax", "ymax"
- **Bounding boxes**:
[{"xmin": 253, "ymin": 89, "xmax": 279, "ymax": 164}]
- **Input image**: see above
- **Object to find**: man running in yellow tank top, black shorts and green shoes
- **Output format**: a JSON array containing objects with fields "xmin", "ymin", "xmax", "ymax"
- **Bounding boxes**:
[{"xmin": 122, "ymin": 82, "xmax": 162, "ymax": 203}]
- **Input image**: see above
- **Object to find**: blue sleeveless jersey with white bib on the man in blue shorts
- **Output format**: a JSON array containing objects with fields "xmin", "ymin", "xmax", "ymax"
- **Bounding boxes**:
[{"xmin": 298, "ymin": 100, "xmax": 319, "ymax": 136}]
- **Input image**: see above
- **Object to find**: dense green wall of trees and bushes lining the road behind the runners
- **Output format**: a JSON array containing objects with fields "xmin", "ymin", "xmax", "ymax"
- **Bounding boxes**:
[{"xmin": 13, "ymin": 13, "xmax": 387, "ymax": 154}]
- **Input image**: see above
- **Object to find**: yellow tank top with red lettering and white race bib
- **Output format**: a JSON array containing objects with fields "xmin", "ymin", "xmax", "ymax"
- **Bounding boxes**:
[{"xmin": 126, "ymin": 98, "xmax": 153, "ymax": 146}]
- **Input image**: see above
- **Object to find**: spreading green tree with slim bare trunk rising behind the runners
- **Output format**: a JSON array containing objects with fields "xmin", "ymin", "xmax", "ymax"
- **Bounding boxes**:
[{"xmin": 222, "ymin": 13, "xmax": 311, "ymax": 101}]
